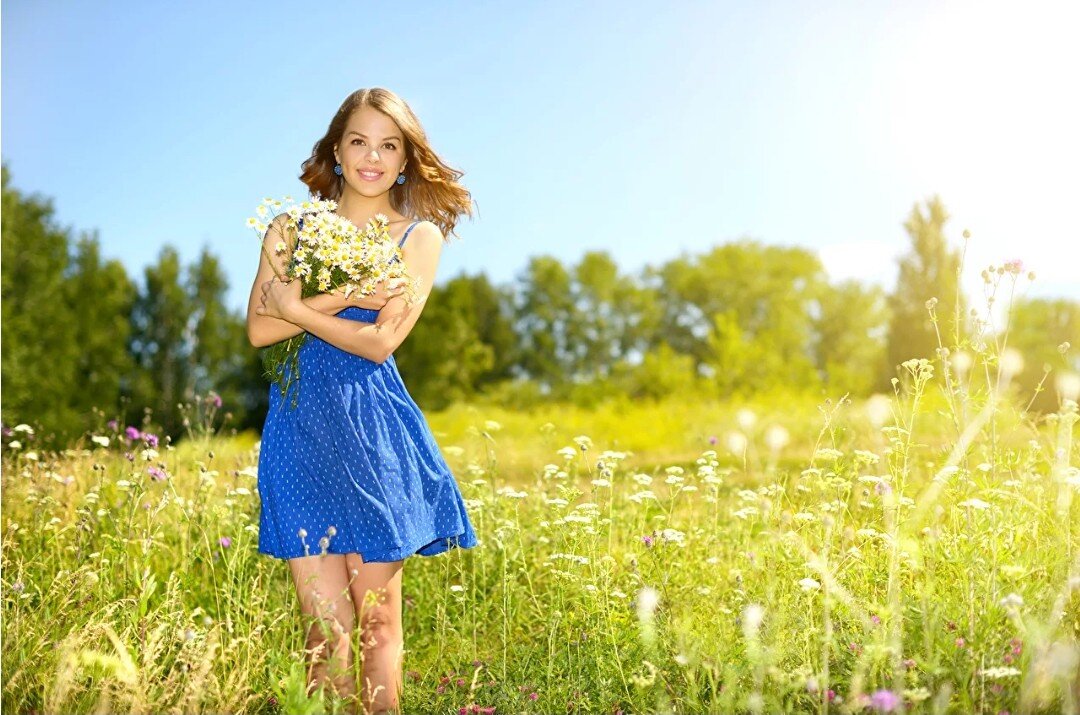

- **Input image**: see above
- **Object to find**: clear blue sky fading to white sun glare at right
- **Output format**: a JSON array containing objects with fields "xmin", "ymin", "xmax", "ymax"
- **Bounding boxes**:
[{"xmin": 0, "ymin": 0, "xmax": 1080, "ymax": 310}]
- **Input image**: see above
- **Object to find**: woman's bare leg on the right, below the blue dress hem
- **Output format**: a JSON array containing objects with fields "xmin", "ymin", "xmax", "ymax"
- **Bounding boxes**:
[{"xmin": 346, "ymin": 554, "xmax": 404, "ymax": 715}]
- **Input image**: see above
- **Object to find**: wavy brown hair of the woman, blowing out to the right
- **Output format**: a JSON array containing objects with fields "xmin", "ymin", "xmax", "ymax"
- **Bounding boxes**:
[{"xmin": 300, "ymin": 86, "xmax": 473, "ymax": 239}]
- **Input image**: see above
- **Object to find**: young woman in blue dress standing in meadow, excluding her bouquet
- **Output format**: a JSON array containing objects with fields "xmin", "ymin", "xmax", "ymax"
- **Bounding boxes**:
[{"xmin": 247, "ymin": 87, "xmax": 476, "ymax": 712}]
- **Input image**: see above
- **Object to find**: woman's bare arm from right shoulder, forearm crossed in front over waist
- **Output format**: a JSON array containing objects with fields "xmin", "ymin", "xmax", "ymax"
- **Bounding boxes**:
[{"xmin": 271, "ymin": 221, "xmax": 443, "ymax": 363}]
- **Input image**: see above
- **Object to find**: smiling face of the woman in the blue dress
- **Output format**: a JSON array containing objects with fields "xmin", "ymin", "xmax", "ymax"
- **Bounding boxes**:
[{"xmin": 334, "ymin": 106, "xmax": 405, "ymax": 197}]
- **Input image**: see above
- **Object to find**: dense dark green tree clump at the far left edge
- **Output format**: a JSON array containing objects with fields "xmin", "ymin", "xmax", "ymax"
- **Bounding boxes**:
[{"xmin": 0, "ymin": 164, "xmax": 133, "ymax": 444}]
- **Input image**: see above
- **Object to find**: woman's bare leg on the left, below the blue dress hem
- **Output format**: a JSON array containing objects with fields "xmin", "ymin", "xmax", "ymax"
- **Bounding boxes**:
[{"xmin": 288, "ymin": 554, "xmax": 356, "ymax": 698}]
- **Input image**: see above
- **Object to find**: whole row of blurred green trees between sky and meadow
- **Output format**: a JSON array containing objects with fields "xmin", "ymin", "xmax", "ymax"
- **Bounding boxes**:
[{"xmin": 0, "ymin": 165, "xmax": 1080, "ymax": 444}]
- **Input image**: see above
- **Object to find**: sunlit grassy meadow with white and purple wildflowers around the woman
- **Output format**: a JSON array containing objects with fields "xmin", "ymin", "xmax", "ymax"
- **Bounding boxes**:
[{"xmin": 2, "ymin": 346, "xmax": 1080, "ymax": 714}]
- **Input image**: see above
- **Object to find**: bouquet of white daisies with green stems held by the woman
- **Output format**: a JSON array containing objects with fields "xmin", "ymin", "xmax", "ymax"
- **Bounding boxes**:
[{"xmin": 247, "ymin": 197, "xmax": 420, "ymax": 407}]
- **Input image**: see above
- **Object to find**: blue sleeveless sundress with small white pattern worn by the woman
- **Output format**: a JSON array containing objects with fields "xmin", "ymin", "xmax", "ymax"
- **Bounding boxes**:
[{"xmin": 258, "ymin": 221, "xmax": 477, "ymax": 562}]
